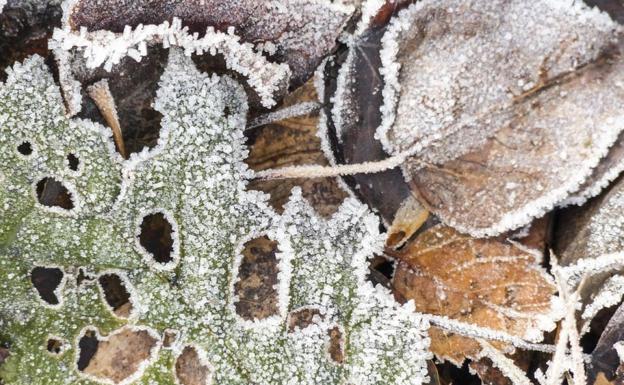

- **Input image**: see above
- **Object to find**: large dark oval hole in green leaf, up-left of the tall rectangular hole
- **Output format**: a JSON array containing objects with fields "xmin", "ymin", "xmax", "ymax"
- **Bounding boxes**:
[{"xmin": 139, "ymin": 213, "xmax": 173, "ymax": 264}]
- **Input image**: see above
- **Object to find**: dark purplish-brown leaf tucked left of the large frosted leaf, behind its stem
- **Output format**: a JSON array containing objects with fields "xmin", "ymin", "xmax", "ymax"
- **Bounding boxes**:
[{"xmin": 319, "ymin": 10, "xmax": 411, "ymax": 224}]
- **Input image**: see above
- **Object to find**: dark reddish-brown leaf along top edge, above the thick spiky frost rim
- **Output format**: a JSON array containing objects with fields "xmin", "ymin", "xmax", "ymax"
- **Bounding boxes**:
[{"xmin": 68, "ymin": 0, "xmax": 350, "ymax": 86}]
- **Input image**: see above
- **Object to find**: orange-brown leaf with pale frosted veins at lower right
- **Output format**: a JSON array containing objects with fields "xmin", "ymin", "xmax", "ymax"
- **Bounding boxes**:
[{"xmin": 393, "ymin": 225, "xmax": 556, "ymax": 366}]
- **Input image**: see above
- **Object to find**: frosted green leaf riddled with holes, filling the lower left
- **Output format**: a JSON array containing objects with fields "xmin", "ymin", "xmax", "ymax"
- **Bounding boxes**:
[{"xmin": 0, "ymin": 50, "xmax": 428, "ymax": 385}]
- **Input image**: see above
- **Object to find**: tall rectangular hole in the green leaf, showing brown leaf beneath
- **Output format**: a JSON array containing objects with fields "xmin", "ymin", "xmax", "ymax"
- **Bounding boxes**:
[{"xmin": 234, "ymin": 236, "xmax": 278, "ymax": 320}]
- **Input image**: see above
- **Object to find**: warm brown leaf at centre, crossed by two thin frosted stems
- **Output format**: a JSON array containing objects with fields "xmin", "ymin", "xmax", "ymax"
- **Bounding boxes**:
[{"xmin": 246, "ymin": 82, "xmax": 347, "ymax": 216}]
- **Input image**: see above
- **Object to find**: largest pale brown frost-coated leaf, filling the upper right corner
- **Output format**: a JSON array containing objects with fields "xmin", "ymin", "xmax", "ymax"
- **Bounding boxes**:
[{"xmin": 393, "ymin": 1, "xmax": 624, "ymax": 236}]
